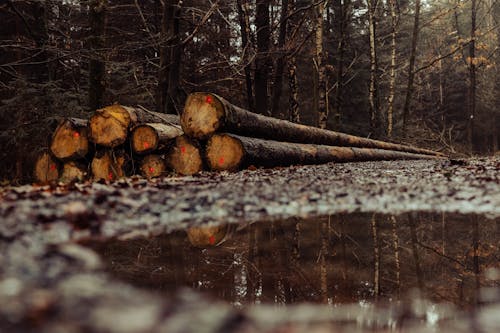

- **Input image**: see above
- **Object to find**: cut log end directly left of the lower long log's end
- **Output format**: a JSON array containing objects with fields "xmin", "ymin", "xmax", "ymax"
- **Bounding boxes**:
[{"xmin": 165, "ymin": 135, "xmax": 203, "ymax": 176}]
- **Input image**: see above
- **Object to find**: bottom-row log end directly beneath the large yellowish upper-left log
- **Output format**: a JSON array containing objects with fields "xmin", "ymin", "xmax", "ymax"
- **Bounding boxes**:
[{"xmin": 91, "ymin": 149, "xmax": 129, "ymax": 181}]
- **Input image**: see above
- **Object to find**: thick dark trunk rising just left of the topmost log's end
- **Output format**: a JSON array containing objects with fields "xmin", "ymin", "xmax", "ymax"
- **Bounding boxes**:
[{"xmin": 156, "ymin": 0, "xmax": 182, "ymax": 114}]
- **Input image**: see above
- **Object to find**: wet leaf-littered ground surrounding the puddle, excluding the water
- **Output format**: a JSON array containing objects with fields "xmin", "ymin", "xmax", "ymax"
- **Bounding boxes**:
[{"xmin": 0, "ymin": 157, "xmax": 500, "ymax": 332}]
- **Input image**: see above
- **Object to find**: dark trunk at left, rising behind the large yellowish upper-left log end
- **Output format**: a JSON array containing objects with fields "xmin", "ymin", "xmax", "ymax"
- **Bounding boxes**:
[{"xmin": 89, "ymin": 0, "xmax": 108, "ymax": 110}]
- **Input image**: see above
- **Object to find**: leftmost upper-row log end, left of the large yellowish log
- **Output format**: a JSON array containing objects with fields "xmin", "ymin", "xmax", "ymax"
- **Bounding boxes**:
[{"xmin": 50, "ymin": 118, "xmax": 89, "ymax": 161}]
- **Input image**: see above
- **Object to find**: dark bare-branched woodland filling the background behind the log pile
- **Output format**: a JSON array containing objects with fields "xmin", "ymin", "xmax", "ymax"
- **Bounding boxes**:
[{"xmin": 0, "ymin": 0, "xmax": 500, "ymax": 182}]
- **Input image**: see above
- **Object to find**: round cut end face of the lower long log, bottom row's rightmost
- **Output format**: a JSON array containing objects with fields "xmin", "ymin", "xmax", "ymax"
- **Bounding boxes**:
[{"xmin": 206, "ymin": 134, "xmax": 244, "ymax": 171}]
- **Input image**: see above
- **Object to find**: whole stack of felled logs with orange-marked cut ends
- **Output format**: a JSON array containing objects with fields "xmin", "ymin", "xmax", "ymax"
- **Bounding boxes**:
[{"xmin": 35, "ymin": 93, "xmax": 443, "ymax": 183}]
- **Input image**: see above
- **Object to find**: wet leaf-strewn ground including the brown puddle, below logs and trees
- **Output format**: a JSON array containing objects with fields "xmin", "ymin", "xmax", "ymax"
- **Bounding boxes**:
[{"xmin": 0, "ymin": 158, "xmax": 500, "ymax": 333}]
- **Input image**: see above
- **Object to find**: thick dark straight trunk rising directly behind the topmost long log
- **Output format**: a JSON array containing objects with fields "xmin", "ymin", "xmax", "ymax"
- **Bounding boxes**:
[{"xmin": 254, "ymin": 0, "xmax": 271, "ymax": 114}]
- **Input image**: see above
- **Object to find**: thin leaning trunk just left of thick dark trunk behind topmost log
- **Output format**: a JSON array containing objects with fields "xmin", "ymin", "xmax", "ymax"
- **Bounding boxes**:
[{"xmin": 236, "ymin": 0, "xmax": 255, "ymax": 112}]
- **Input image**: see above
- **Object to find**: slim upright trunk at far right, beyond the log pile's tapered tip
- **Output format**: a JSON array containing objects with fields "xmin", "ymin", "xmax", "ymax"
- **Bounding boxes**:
[{"xmin": 467, "ymin": 0, "xmax": 477, "ymax": 154}]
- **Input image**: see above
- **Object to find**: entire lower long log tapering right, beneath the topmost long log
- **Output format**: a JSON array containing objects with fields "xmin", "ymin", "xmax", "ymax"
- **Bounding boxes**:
[{"xmin": 206, "ymin": 133, "xmax": 439, "ymax": 171}]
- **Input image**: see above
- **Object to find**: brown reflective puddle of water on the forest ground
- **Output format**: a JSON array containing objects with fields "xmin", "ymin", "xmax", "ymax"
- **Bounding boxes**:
[{"xmin": 84, "ymin": 213, "xmax": 500, "ymax": 308}]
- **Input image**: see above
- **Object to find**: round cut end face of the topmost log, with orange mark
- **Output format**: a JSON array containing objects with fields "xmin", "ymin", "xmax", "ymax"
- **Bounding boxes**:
[{"xmin": 181, "ymin": 93, "xmax": 224, "ymax": 139}]
